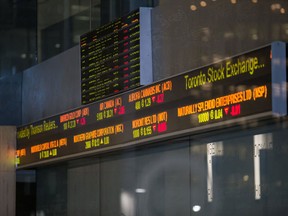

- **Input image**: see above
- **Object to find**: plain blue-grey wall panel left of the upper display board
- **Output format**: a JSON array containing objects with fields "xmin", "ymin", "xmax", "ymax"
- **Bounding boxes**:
[{"xmin": 22, "ymin": 46, "xmax": 81, "ymax": 124}]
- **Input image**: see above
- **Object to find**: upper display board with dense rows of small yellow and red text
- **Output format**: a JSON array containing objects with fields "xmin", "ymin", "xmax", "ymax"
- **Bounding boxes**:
[{"xmin": 80, "ymin": 8, "xmax": 152, "ymax": 104}]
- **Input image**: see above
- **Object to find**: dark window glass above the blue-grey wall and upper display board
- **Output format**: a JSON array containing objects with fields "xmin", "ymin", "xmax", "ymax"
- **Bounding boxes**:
[{"xmin": 37, "ymin": 0, "xmax": 154, "ymax": 62}]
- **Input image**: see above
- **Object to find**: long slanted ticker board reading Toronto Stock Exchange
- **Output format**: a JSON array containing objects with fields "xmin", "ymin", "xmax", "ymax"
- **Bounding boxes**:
[{"xmin": 17, "ymin": 41, "xmax": 287, "ymax": 168}]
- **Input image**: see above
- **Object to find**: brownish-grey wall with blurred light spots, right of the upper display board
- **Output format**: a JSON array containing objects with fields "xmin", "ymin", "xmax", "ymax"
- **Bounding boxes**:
[{"xmin": 152, "ymin": 0, "xmax": 288, "ymax": 80}]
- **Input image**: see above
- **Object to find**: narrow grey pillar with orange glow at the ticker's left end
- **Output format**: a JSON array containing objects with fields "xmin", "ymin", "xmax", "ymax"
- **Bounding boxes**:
[{"xmin": 0, "ymin": 126, "xmax": 16, "ymax": 216}]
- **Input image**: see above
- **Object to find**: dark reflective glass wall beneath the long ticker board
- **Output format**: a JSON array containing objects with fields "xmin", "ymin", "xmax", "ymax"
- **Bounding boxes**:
[{"xmin": 33, "ymin": 122, "xmax": 288, "ymax": 216}]
